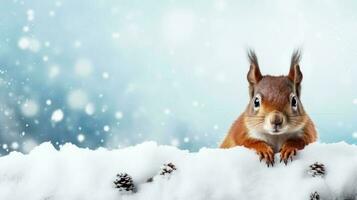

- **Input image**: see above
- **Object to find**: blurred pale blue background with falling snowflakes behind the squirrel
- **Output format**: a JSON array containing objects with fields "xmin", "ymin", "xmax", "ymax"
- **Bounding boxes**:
[{"xmin": 0, "ymin": 0, "xmax": 357, "ymax": 155}]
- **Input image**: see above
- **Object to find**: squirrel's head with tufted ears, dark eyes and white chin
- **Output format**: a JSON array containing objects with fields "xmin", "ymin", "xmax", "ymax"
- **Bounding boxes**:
[{"xmin": 245, "ymin": 50, "xmax": 307, "ymax": 135}]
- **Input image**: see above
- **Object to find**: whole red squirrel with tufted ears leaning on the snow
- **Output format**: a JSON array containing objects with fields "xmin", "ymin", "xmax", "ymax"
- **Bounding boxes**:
[{"xmin": 220, "ymin": 49, "xmax": 317, "ymax": 167}]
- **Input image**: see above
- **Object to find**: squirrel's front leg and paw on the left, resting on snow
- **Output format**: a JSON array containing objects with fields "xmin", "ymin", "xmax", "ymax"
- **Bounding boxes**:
[{"xmin": 242, "ymin": 138, "xmax": 274, "ymax": 167}]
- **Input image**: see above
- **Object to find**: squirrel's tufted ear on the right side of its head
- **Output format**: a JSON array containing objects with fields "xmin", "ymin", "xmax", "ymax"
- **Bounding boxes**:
[{"xmin": 288, "ymin": 49, "xmax": 303, "ymax": 96}]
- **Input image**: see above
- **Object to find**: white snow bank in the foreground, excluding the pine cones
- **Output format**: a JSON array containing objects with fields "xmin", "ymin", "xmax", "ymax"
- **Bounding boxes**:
[{"xmin": 0, "ymin": 142, "xmax": 357, "ymax": 200}]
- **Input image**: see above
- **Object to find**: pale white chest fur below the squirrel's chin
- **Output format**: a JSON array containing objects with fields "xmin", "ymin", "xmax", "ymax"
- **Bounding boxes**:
[{"xmin": 249, "ymin": 131, "xmax": 302, "ymax": 152}]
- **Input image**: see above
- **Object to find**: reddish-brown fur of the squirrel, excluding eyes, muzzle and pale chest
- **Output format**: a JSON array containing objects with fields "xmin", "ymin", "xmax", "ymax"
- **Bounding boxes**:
[{"xmin": 220, "ymin": 52, "xmax": 317, "ymax": 166}]
